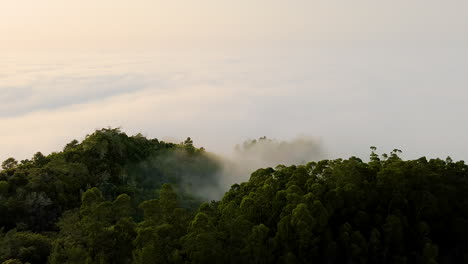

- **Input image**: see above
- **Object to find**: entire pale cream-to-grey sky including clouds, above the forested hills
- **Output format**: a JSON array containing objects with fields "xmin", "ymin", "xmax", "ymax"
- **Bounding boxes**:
[{"xmin": 0, "ymin": 0, "xmax": 468, "ymax": 163}]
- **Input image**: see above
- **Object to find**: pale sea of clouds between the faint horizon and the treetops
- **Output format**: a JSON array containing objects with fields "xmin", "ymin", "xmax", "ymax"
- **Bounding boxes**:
[{"xmin": 0, "ymin": 48, "xmax": 468, "ymax": 163}]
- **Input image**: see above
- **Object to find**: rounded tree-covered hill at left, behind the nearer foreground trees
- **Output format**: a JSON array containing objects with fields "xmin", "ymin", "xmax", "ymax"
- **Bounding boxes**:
[{"xmin": 0, "ymin": 129, "xmax": 221, "ymax": 232}]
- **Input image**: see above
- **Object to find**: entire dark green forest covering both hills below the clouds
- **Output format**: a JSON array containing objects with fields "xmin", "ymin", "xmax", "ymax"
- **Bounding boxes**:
[{"xmin": 0, "ymin": 128, "xmax": 468, "ymax": 264}]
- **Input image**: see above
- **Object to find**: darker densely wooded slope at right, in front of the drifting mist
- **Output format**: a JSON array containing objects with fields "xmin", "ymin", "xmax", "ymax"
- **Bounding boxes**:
[{"xmin": 176, "ymin": 150, "xmax": 468, "ymax": 263}]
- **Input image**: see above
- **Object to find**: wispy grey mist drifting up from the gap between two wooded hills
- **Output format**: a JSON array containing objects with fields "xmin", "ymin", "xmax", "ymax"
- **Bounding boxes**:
[{"xmin": 183, "ymin": 135, "xmax": 327, "ymax": 200}]
